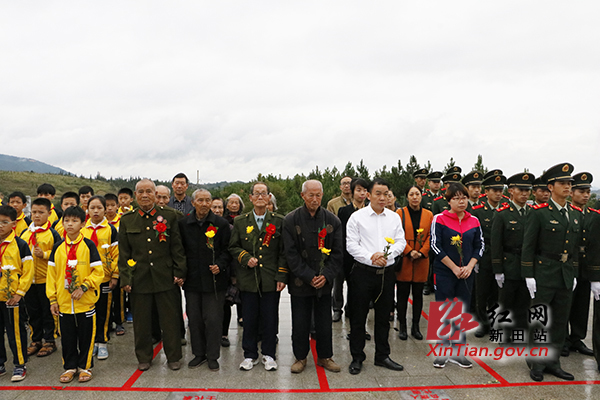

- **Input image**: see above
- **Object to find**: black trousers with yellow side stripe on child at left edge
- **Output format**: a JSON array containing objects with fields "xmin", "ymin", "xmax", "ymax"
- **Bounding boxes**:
[{"xmin": 0, "ymin": 299, "xmax": 27, "ymax": 366}]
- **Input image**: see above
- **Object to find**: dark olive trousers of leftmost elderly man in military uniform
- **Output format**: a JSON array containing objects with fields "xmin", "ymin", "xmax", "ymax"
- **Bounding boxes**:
[{"xmin": 129, "ymin": 286, "xmax": 181, "ymax": 363}]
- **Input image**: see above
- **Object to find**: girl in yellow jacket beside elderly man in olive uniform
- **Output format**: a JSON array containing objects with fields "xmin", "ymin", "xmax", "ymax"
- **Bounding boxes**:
[{"xmin": 83, "ymin": 196, "xmax": 119, "ymax": 360}]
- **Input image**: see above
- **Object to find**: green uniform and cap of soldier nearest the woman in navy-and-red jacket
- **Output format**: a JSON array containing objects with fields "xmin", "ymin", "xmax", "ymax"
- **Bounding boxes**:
[{"xmin": 471, "ymin": 175, "xmax": 506, "ymax": 337}]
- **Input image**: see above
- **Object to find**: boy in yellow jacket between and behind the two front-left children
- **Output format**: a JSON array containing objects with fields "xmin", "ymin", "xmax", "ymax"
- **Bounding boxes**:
[{"xmin": 21, "ymin": 197, "xmax": 62, "ymax": 357}]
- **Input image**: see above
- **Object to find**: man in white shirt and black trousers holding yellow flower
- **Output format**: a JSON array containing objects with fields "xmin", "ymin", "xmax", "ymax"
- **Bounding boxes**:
[{"xmin": 346, "ymin": 178, "xmax": 406, "ymax": 375}]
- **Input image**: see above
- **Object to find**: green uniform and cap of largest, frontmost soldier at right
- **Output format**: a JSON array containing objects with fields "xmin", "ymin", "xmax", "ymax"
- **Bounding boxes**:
[{"xmin": 521, "ymin": 163, "xmax": 582, "ymax": 380}]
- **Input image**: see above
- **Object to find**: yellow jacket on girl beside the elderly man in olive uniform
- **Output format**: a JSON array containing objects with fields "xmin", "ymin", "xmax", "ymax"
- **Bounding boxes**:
[{"xmin": 81, "ymin": 218, "xmax": 119, "ymax": 283}]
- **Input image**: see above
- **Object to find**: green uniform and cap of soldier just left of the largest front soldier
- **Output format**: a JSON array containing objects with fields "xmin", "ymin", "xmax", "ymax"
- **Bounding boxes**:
[{"xmin": 486, "ymin": 172, "xmax": 535, "ymax": 341}]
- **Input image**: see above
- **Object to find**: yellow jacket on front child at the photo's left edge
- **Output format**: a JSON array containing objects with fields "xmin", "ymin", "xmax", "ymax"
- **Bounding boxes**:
[{"xmin": 0, "ymin": 232, "xmax": 33, "ymax": 301}]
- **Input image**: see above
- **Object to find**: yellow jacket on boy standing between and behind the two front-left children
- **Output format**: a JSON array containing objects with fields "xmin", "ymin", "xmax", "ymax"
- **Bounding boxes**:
[{"xmin": 21, "ymin": 221, "xmax": 61, "ymax": 284}]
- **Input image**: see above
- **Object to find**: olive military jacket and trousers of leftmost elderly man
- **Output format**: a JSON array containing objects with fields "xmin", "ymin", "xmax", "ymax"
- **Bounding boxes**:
[{"xmin": 119, "ymin": 207, "xmax": 187, "ymax": 363}]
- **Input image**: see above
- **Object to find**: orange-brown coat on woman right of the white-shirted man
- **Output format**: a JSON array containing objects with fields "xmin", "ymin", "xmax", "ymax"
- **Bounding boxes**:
[{"xmin": 396, "ymin": 207, "xmax": 433, "ymax": 282}]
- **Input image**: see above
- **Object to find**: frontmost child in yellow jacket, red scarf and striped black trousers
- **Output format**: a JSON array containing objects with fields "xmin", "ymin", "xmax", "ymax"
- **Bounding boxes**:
[{"xmin": 46, "ymin": 207, "xmax": 104, "ymax": 383}]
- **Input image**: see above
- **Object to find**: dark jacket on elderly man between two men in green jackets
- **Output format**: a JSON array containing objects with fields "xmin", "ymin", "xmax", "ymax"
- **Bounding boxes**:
[{"xmin": 179, "ymin": 210, "xmax": 231, "ymax": 293}]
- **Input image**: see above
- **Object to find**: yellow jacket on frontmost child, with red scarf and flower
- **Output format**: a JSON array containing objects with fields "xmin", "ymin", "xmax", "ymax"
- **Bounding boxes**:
[{"xmin": 46, "ymin": 233, "xmax": 104, "ymax": 314}]
